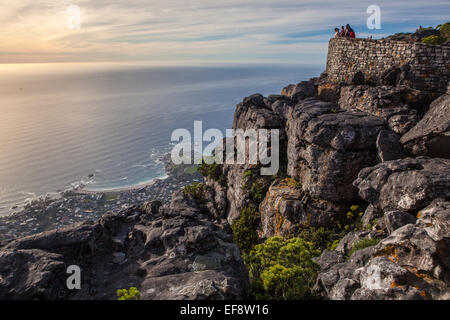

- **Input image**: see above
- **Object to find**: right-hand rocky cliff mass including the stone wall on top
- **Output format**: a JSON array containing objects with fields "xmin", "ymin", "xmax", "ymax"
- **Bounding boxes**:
[{"xmin": 205, "ymin": 39, "xmax": 450, "ymax": 299}]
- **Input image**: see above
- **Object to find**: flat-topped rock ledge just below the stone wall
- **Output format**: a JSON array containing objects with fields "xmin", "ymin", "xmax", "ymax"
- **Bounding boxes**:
[{"xmin": 339, "ymin": 86, "xmax": 419, "ymax": 135}]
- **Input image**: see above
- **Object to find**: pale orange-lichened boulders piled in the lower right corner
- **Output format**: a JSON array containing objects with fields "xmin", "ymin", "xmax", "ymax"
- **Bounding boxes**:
[{"xmin": 315, "ymin": 139, "xmax": 450, "ymax": 300}]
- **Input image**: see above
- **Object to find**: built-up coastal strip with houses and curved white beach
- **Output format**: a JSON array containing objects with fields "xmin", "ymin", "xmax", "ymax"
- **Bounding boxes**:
[{"xmin": 0, "ymin": 155, "xmax": 203, "ymax": 243}]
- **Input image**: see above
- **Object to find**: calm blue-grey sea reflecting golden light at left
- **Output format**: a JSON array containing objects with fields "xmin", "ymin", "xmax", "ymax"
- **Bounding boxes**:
[{"xmin": 0, "ymin": 64, "xmax": 322, "ymax": 215}]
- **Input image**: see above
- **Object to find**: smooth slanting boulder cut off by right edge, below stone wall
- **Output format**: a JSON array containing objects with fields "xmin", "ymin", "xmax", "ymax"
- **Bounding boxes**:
[{"xmin": 400, "ymin": 94, "xmax": 450, "ymax": 159}]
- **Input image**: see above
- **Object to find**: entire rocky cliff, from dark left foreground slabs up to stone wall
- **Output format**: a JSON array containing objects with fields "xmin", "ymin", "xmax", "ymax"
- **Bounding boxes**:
[{"xmin": 0, "ymin": 39, "xmax": 450, "ymax": 299}]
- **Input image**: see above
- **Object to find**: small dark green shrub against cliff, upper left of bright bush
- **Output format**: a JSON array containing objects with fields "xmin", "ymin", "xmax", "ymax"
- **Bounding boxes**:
[{"xmin": 231, "ymin": 207, "xmax": 260, "ymax": 254}]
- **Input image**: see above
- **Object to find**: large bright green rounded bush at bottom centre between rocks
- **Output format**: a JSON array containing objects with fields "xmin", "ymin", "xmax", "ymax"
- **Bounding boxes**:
[{"xmin": 245, "ymin": 237, "xmax": 320, "ymax": 300}]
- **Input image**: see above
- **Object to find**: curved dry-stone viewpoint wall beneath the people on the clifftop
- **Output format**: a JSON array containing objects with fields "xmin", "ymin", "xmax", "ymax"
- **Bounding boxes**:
[{"xmin": 326, "ymin": 38, "xmax": 450, "ymax": 93}]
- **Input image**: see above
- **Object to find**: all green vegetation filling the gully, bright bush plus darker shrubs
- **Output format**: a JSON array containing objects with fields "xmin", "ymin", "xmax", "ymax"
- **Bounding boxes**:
[{"xmin": 231, "ymin": 200, "xmax": 370, "ymax": 299}]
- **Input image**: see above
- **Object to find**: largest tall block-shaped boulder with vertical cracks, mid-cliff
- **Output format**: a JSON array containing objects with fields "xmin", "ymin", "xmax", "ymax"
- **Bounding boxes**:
[{"xmin": 287, "ymin": 99, "xmax": 385, "ymax": 201}]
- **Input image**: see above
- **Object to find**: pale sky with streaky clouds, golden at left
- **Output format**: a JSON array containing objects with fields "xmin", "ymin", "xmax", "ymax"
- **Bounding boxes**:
[{"xmin": 0, "ymin": 0, "xmax": 450, "ymax": 65}]
